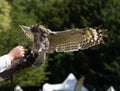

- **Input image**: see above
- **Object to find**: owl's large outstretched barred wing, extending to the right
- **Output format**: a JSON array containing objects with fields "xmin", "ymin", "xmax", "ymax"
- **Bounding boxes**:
[{"xmin": 48, "ymin": 28, "xmax": 106, "ymax": 52}]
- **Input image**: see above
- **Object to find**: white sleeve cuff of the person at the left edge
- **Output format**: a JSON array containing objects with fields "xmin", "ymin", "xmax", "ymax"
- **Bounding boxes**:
[{"xmin": 0, "ymin": 55, "xmax": 11, "ymax": 73}]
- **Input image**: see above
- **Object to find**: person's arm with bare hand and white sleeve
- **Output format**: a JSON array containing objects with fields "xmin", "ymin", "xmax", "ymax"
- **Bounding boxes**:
[{"xmin": 0, "ymin": 46, "xmax": 25, "ymax": 73}]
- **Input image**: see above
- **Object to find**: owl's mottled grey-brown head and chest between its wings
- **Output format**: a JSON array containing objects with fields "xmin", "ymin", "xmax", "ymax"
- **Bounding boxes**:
[{"xmin": 27, "ymin": 25, "xmax": 50, "ymax": 52}]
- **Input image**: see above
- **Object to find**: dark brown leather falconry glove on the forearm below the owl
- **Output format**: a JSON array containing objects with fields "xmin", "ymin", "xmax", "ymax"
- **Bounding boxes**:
[{"xmin": 0, "ymin": 49, "xmax": 37, "ymax": 81}]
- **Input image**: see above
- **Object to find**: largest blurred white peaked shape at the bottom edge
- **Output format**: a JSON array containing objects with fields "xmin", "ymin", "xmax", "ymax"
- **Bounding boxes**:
[{"xmin": 43, "ymin": 73, "xmax": 77, "ymax": 91}]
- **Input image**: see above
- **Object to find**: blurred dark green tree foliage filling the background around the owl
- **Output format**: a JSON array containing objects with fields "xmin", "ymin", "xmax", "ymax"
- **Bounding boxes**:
[{"xmin": 0, "ymin": 0, "xmax": 120, "ymax": 91}]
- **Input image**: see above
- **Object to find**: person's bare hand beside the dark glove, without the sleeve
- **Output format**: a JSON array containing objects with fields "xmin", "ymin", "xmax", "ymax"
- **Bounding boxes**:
[{"xmin": 8, "ymin": 46, "xmax": 25, "ymax": 61}]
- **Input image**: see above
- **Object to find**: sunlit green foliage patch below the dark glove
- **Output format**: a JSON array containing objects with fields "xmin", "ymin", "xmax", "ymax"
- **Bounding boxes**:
[{"xmin": 14, "ymin": 65, "xmax": 50, "ymax": 86}]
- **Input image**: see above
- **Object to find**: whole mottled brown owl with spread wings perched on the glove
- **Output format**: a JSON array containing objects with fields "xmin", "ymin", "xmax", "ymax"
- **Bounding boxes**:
[{"xmin": 20, "ymin": 24, "xmax": 106, "ymax": 66}]
